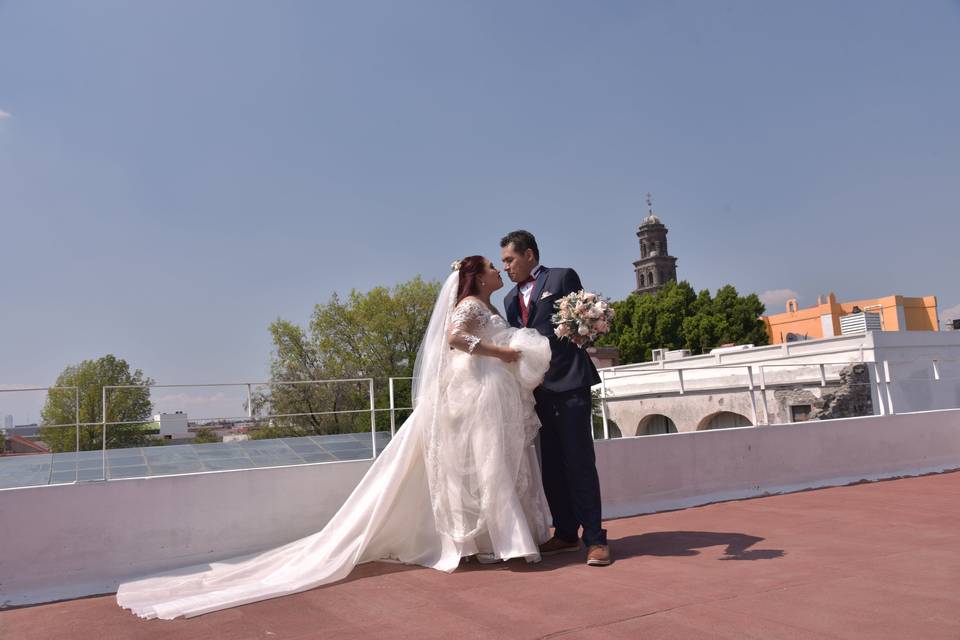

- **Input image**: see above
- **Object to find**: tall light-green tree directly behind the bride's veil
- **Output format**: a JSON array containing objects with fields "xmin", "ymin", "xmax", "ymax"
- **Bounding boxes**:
[{"xmin": 252, "ymin": 276, "xmax": 440, "ymax": 438}]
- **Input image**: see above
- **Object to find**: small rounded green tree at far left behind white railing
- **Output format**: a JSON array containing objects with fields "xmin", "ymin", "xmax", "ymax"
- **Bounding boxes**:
[{"xmin": 40, "ymin": 355, "xmax": 153, "ymax": 453}]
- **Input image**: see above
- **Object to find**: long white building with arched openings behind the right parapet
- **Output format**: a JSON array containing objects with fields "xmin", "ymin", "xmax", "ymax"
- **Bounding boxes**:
[{"xmin": 595, "ymin": 331, "xmax": 960, "ymax": 436}]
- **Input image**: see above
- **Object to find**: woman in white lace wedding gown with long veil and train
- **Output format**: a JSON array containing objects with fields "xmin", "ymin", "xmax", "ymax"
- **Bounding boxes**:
[{"xmin": 117, "ymin": 256, "xmax": 550, "ymax": 620}]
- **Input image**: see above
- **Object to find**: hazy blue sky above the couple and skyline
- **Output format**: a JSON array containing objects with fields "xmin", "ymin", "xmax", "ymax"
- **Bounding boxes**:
[{"xmin": 0, "ymin": 0, "xmax": 960, "ymax": 422}]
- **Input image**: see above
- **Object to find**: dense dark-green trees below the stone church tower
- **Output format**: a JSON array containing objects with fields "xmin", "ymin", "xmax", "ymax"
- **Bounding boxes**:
[{"xmin": 597, "ymin": 281, "xmax": 768, "ymax": 364}]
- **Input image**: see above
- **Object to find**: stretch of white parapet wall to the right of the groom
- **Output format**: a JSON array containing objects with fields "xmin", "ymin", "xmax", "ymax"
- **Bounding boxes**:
[{"xmin": 596, "ymin": 409, "xmax": 960, "ymax": 518}]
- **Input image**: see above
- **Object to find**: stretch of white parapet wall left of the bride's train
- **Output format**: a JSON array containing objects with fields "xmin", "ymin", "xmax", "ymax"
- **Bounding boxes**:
[{"xmin": 0, "ymin": 460, "xmax": 371, "ymax": 607}]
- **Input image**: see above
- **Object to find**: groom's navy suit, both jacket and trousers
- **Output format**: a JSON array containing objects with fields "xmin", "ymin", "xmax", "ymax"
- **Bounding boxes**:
[{"xmin": 504, "ymin": 267, "xmax": 607, "ymax": 545}]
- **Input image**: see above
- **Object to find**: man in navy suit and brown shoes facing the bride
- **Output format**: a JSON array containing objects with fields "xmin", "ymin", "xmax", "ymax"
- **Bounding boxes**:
[{"xmin": 500, "ymin": 230, "xmax": 610, "ymax": 566}]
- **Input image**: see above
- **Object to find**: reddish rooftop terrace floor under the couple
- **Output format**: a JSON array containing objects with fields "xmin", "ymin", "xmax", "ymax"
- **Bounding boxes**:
[{"xmin": 0, "ymin": 473, "xmax": 960, "ymax": 640}]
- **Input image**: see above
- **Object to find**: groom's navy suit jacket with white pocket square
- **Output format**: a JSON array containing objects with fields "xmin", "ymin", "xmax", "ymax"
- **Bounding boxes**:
[{"xmin": 504, "ymin": 266, "xmax": 600, "ymax": 393}]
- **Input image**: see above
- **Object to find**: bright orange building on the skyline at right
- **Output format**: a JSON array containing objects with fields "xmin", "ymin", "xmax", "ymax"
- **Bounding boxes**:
[{"xmin": 763, "ymin": 293, "xmax": 939, "ymax": 344}]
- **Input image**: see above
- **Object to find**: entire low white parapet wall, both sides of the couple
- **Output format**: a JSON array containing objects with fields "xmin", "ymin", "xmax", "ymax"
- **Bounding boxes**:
[{"xmin": 0, "ymin": 410, "xmax": 960, "ymax": 606}]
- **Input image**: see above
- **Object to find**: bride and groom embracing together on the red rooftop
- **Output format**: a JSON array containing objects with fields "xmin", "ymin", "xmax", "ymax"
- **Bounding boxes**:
[{"xmin": 117, "ymin": 230, "xmax": 610, "ymax": 619}]
